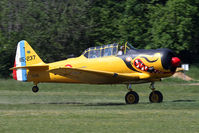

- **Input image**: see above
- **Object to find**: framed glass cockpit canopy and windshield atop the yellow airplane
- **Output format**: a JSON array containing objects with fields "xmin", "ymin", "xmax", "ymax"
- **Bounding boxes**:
[{"xmin": 82, "ymin": 43, "xmax": 135, "ymax": 58}]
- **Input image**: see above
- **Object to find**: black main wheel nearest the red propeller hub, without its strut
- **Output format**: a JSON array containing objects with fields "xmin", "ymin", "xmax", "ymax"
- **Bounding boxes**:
[{"xmin": 149, "ymin": 91, "xmax": 163, "ymax": 103}]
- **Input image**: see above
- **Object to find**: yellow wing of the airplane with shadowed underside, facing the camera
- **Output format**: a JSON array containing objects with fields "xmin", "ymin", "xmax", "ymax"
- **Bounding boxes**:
[{"xmin": 49, "ymin": 67, "xmax": 150, "ymax": 84}]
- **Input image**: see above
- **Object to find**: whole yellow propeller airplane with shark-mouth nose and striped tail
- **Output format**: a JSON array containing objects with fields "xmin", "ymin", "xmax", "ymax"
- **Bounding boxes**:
[{"xmin": 10, "ymin": 40, "xmax": 180, "ymax": 104}]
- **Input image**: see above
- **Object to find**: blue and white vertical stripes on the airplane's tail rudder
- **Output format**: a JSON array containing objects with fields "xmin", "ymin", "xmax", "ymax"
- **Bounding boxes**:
[{"xmin": 15, "ymin": 40, "xmax": 27, "ymax": 82}]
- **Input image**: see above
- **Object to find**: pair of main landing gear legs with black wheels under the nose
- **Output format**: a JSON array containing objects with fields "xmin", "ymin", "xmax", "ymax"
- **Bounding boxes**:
[{"xmin": 125, "ymin": 82, "xmax": 163, "ymax": 104}]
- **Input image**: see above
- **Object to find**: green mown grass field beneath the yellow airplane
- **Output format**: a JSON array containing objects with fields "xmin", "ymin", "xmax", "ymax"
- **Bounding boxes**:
[{"xmin": 0, "ymin": 80, "xmax": 199, "ymax": 133}]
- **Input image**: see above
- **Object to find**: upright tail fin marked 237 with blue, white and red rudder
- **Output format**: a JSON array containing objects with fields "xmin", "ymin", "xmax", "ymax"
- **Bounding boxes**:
[{"xmin": 13, "ymin": 40, "xmax": 45, "ymax": 81}]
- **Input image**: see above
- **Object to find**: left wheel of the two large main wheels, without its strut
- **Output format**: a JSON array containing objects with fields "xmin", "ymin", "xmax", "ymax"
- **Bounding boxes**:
[{"xmin": 125, "ymin": 91, "xmax": 139, "ymax": 104}]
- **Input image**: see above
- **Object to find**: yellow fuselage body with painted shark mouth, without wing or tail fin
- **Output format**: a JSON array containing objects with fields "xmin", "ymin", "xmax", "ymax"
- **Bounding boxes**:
[{"xmin": 27, "ymin": 50, "xmax": 177, "ymax": 84}]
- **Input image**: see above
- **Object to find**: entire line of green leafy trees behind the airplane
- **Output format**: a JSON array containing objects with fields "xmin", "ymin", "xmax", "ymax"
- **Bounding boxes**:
[{"xmin": 0, "ymin": 0, "xmax": 199, "ymax": 77}]
